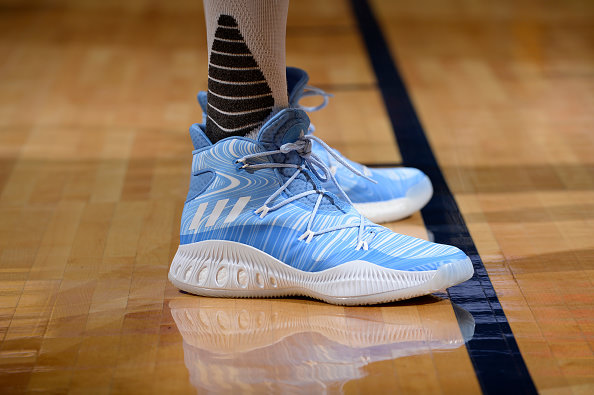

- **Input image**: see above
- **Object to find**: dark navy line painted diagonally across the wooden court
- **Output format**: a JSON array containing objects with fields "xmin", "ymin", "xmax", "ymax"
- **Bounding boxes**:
[{"xmin": 351, "ymin": 0, "xmax": 536, "ymax": 394}]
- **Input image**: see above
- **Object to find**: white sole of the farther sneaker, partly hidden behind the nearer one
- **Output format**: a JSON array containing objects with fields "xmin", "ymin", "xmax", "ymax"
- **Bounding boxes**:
[{"xmin": 353, "ymin": 176, "xmax": 433, "ymax": 223}]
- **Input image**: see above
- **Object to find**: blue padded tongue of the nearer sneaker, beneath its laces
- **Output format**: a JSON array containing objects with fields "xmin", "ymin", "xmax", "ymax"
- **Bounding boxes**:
[{"xmin": 258, "ymin": 108, "xmax": 343, "ymax": 211}]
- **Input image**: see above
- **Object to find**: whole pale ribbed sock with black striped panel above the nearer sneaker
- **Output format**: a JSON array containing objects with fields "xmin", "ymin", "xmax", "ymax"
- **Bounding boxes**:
[{"xmin": 204, "ymin": 0, "xmax": 289, "ymax": 143}]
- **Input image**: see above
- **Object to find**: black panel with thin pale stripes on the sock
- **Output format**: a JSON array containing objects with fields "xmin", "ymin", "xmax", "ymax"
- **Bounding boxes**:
[{"xmin": 206, "ymin": 15, "xmax": 274, "ymax": 143}]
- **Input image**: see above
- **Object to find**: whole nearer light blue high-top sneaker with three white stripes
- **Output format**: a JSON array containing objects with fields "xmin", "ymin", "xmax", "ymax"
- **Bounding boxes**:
[{"xmin": 169, "ymin": 108, "xmax": 473, "ymax": 305}]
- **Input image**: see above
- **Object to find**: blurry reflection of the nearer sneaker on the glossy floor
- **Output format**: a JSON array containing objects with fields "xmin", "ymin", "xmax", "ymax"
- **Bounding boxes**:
[{"xmin": 169, "ymin": 298, "xmax": 474, "ymax": 393}]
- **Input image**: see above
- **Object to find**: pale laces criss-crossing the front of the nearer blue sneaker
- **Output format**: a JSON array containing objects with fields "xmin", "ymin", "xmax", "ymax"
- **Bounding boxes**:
[{"xmin": 236, "ymin": 133, "xmax": 375, "ymax": 250}]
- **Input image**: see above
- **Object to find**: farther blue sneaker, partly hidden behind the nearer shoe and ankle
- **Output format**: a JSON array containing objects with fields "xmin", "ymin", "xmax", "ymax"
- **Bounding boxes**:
[{"xmin": 198, "ymin": 67, "xmax": 433, "ymax": 223}]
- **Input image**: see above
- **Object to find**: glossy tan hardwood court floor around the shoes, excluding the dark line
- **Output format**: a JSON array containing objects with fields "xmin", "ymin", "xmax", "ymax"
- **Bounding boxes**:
[{"xmin": 0, "ymin": 0, "xmax": 594, "ymax": 394}]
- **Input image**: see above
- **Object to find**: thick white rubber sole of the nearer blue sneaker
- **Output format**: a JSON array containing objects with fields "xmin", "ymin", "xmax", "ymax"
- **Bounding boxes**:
[{"xmin": 169, "ymin": 240, "xmax": 474, "ymax": 305}]
